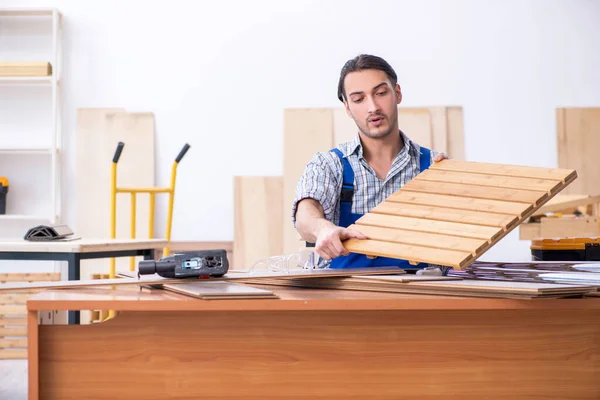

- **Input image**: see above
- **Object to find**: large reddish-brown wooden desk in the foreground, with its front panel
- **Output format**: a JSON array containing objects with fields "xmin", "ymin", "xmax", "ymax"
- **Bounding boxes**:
[{"xmin": 27, "ymin": 286, "xmax": 600, "ymax": 400}]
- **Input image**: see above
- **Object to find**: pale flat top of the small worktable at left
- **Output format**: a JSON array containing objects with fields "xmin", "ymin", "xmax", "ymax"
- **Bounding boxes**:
[{"xmin": 0, "ymin": 238, "xmax": 168, "ymax": 253}]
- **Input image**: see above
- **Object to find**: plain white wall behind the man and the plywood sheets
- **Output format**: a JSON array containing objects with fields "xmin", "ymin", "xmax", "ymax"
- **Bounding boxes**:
[{"xmin": 0, "ymin": 0, "xmax": 600, "ymax": 259}]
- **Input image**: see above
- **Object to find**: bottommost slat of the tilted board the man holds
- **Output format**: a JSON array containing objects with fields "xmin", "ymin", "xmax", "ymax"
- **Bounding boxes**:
[{"xmin": 344, "ymin": 239, "xmax": 473, "ymax": 268}]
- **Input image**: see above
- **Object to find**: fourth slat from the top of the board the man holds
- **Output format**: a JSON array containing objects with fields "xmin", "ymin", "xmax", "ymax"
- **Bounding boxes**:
[{"xmin": 386, "ymin": 190, "xmax": 533, "ymax": 215}]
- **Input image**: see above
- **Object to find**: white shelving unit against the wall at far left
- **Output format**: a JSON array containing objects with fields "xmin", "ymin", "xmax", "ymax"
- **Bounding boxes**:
[{"xmin": 0, "ymin": 8, "xmax": 62, "ymax": 228}]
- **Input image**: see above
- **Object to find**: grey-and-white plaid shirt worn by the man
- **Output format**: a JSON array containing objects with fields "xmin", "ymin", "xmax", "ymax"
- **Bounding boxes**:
[{"xmin": 292, "ymin": 131, "xmax": 439, "ymax": 226}]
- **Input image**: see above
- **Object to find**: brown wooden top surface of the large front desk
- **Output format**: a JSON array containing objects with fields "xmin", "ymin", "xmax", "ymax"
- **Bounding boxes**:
[{"xmin": 27, "ymin": 284, "xmax": 600, "ymax": 311}]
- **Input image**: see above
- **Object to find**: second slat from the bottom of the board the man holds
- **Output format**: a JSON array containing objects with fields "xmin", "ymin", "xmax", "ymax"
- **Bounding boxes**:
[{"xmin": 349, "ymin": 225, "xmax": 487, "ymax": 253}]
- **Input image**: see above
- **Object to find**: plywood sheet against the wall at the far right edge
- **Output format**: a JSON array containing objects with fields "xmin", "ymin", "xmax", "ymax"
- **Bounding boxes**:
[{"xmin": 556, "ymin": 108, "xmax": 600, "ymax": 195}]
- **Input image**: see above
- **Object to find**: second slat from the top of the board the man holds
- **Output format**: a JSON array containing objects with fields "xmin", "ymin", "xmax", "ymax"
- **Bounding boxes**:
[{"xmin": 418, "ymin": 170, "xmax": 561, "ymax": 193}]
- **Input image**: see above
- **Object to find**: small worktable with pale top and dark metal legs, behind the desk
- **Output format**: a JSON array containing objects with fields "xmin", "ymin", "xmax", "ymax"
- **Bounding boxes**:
[{"xmin": 0, "ymin": 239, "xmax": 168, "ymax": 324}]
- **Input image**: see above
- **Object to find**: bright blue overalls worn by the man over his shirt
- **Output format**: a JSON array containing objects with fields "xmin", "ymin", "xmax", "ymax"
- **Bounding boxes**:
[{"xmin": 329, "ymin": 147, "xmax": 431, "ymax": 269}]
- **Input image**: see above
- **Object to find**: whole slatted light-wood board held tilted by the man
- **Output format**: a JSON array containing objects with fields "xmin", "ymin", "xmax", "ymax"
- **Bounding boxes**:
[{"xmin": 344, "ymin": 160, "xmax": 577, "ymax": 269}]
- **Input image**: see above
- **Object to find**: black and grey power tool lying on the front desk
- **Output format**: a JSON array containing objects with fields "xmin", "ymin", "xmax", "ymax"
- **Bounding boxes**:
[{"xmin": 138, "ymin": 250, "xmax": 229, "ymax": 278}]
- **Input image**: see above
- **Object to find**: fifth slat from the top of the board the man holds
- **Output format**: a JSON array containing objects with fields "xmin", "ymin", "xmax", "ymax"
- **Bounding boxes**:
[{"xmin": 371, "ymin": 201, "xmax": 517, "ymax": 227}]
